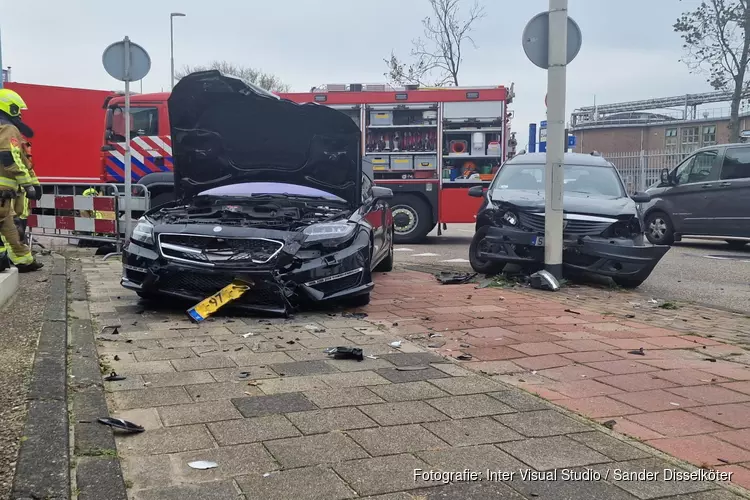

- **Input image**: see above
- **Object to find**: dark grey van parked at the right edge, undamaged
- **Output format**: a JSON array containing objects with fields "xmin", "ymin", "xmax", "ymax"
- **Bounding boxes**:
[{"xmin": 643, "ymin": 143, "xmax": 750, "ymax": 249}]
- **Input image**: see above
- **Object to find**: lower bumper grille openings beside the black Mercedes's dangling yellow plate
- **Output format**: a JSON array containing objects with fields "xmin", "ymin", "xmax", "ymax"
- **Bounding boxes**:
[{"xmin": 158, "ymin": 272, "xmax": 284, "ymax": 306}]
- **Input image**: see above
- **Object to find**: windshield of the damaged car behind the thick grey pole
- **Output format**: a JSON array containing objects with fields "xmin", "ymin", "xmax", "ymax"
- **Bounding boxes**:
[{"xmin": 490, "ymin": 164, "xmax": 626, "ymax": 198}]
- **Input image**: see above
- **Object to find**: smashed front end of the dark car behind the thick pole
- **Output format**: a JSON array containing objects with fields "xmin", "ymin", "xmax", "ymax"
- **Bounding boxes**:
[{"xmin": 471, "ymin": 203, "xmax": 669, "ymax": 287}]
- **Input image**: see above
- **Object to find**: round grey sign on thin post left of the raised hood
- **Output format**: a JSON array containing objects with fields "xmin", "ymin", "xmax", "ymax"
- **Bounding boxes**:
[{"xmin": 102, "ymin": 37, "xmax": 151, "ymax": 240}]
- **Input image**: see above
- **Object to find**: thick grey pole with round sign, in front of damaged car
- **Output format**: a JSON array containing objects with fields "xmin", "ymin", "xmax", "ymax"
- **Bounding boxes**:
[{"xmin": 522, "ymin": 0, "xmax": 581, "ymax": 279}]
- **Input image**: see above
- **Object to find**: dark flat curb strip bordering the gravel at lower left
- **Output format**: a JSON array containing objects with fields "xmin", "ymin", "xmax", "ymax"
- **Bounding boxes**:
[{"xmin": 11, "ymin": 255, "xmax": 70, "ymax": 500}]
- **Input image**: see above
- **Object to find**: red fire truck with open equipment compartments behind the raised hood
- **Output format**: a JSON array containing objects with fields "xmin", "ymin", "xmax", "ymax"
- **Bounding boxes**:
[{"xmin": 101, "ymin": 84, "xmax": 515, "ymax": 243}]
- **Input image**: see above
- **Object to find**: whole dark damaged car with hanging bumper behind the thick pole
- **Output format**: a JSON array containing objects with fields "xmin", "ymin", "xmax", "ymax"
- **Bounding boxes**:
[{"xmin": 469, "ymin": 153, "xmax": 669, "ymax": 288}]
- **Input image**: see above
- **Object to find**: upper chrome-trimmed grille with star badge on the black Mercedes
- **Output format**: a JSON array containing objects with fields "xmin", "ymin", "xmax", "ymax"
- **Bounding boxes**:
[{"xmin": 159, "ymin": 233, "xmax": 284, "ymax": 265}]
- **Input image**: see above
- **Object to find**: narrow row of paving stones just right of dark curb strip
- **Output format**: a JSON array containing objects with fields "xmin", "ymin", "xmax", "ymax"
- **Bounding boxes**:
[{"xmin": 68, "ymin": 262, "xmax": 127, "ymax": 500}]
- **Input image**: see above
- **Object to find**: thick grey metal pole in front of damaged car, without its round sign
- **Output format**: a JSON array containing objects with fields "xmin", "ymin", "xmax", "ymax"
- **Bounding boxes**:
[{"xmin": 544, "ymin": 0, "xmax": 568, "ymax": 279}]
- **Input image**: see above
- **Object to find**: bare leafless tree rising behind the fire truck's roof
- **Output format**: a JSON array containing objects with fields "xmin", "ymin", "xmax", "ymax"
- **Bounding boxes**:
[{"xmin": 384, "ymin": 0, "xmax": 485, "ymax": 87}]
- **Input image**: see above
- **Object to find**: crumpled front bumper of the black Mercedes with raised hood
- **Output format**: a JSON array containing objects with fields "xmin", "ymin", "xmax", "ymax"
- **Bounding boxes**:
[{"xmin": 120, "ymin": 230, "xmax": 374, "ymax": 314}]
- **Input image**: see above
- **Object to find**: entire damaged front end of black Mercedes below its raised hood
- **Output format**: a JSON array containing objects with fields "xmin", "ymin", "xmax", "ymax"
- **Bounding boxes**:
[{"xmin": 122, "ymin": 188, "xmax": 373, "ymax": 314}]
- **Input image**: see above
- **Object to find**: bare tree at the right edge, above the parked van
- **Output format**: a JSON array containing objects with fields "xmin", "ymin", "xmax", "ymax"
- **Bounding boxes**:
[{"xmin": 673, "ymin": 0, "xmax": 750, "ymax": 142}]
